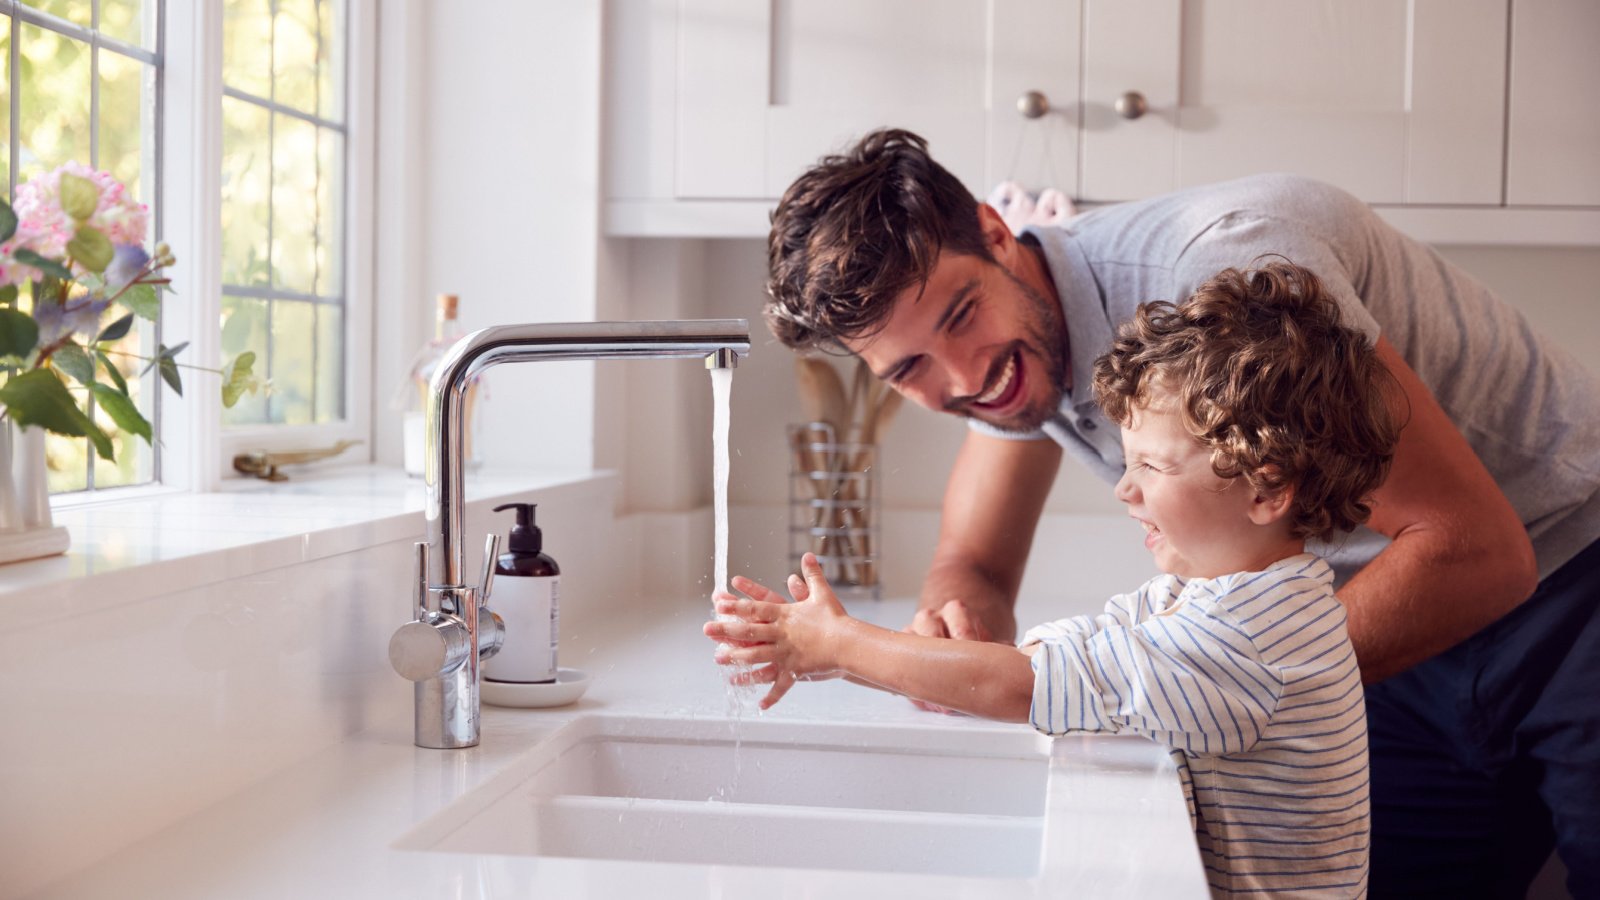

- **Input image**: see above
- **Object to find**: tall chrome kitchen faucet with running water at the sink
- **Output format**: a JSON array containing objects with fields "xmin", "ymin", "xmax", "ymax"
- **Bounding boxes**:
[{"xmin": 389, "ymin": 319, "xmax": 750, "ymax": 749}]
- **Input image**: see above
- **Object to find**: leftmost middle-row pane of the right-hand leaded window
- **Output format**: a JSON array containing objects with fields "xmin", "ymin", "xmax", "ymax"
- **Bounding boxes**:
[{"xmin": 222, "ymin": 98, "xmax": 272, "ymax": 283}]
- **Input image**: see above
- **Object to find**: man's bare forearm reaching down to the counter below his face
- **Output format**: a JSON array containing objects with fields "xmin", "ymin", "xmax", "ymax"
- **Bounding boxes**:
[{"xmin": 909, "ymin": 431, "xmax": 1061, "ymax": 642}]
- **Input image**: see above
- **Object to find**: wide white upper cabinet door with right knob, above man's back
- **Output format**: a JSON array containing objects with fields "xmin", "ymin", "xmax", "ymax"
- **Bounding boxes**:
[{"xmin": 1082, "ymin": 0, "xmax": 1504, "ymax": 203}]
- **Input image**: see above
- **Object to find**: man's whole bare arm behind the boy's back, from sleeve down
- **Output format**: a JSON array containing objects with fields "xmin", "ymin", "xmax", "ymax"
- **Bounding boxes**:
[{"xmin": 1339, "ymin": 338, "xmax": 1539, "ymax": 684}]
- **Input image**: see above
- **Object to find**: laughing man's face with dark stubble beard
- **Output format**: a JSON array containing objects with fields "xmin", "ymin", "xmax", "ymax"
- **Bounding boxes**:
[{"xmin": 845, "ymin": 207, "xmax": 1067, "ymax": 431}]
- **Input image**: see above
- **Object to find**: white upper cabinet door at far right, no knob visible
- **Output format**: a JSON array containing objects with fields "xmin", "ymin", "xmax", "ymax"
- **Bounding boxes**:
[{"xmin": 1506, "ymin": 0, "xmax": 1600, "ymax": 207}]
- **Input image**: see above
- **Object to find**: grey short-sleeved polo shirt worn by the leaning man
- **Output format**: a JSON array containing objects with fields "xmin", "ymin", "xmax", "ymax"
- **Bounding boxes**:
[{"xmin": 971, "ymin": 175, "xmax": 1600, "ymax": 578}]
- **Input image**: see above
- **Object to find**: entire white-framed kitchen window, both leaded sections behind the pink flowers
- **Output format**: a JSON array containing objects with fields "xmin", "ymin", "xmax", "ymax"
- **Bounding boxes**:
[{"xmin": 0, "ymin": 0, "xmax": 378, "ymax": 503}]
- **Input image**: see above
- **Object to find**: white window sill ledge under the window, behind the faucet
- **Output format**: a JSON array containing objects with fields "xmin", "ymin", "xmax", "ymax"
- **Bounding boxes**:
[{"xmin": 10, "ymin": 464, "xmax": 611, "ymax": 615}]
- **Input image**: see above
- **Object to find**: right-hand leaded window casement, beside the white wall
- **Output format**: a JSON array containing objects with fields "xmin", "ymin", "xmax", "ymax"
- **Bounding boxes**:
[{"xmin": 218, "ymin": 0, "xmax": 371, "ymax": 474}]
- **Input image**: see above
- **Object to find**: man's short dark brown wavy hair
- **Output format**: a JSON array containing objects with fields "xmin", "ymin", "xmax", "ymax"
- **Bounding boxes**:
[{"xmin": 763, "ymin": 128, "xmax": 992, "ymax": 351}]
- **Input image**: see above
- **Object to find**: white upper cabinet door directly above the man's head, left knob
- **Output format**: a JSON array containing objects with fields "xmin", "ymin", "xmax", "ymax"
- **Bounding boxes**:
[{"xmin": 674, "ymin": 0, "xmax": 1080, "ymax": 199}]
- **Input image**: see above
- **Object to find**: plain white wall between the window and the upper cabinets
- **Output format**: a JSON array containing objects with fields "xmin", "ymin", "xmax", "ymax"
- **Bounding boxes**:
[{"xmin": 374, "ymin": 0, "xmax": 600, "ymax": 469}]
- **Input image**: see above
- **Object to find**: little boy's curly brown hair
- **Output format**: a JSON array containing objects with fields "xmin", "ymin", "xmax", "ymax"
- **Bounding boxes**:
[{"xmin": 1094, "ymin": 261, "xmax": 1400, "ymax": 538}]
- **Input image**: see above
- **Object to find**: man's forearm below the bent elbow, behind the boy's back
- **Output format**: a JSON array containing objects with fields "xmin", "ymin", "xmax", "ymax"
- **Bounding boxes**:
[{"xmin": 1339, "ymin": 522, "xmax": 1534, "ymax": 684}]
